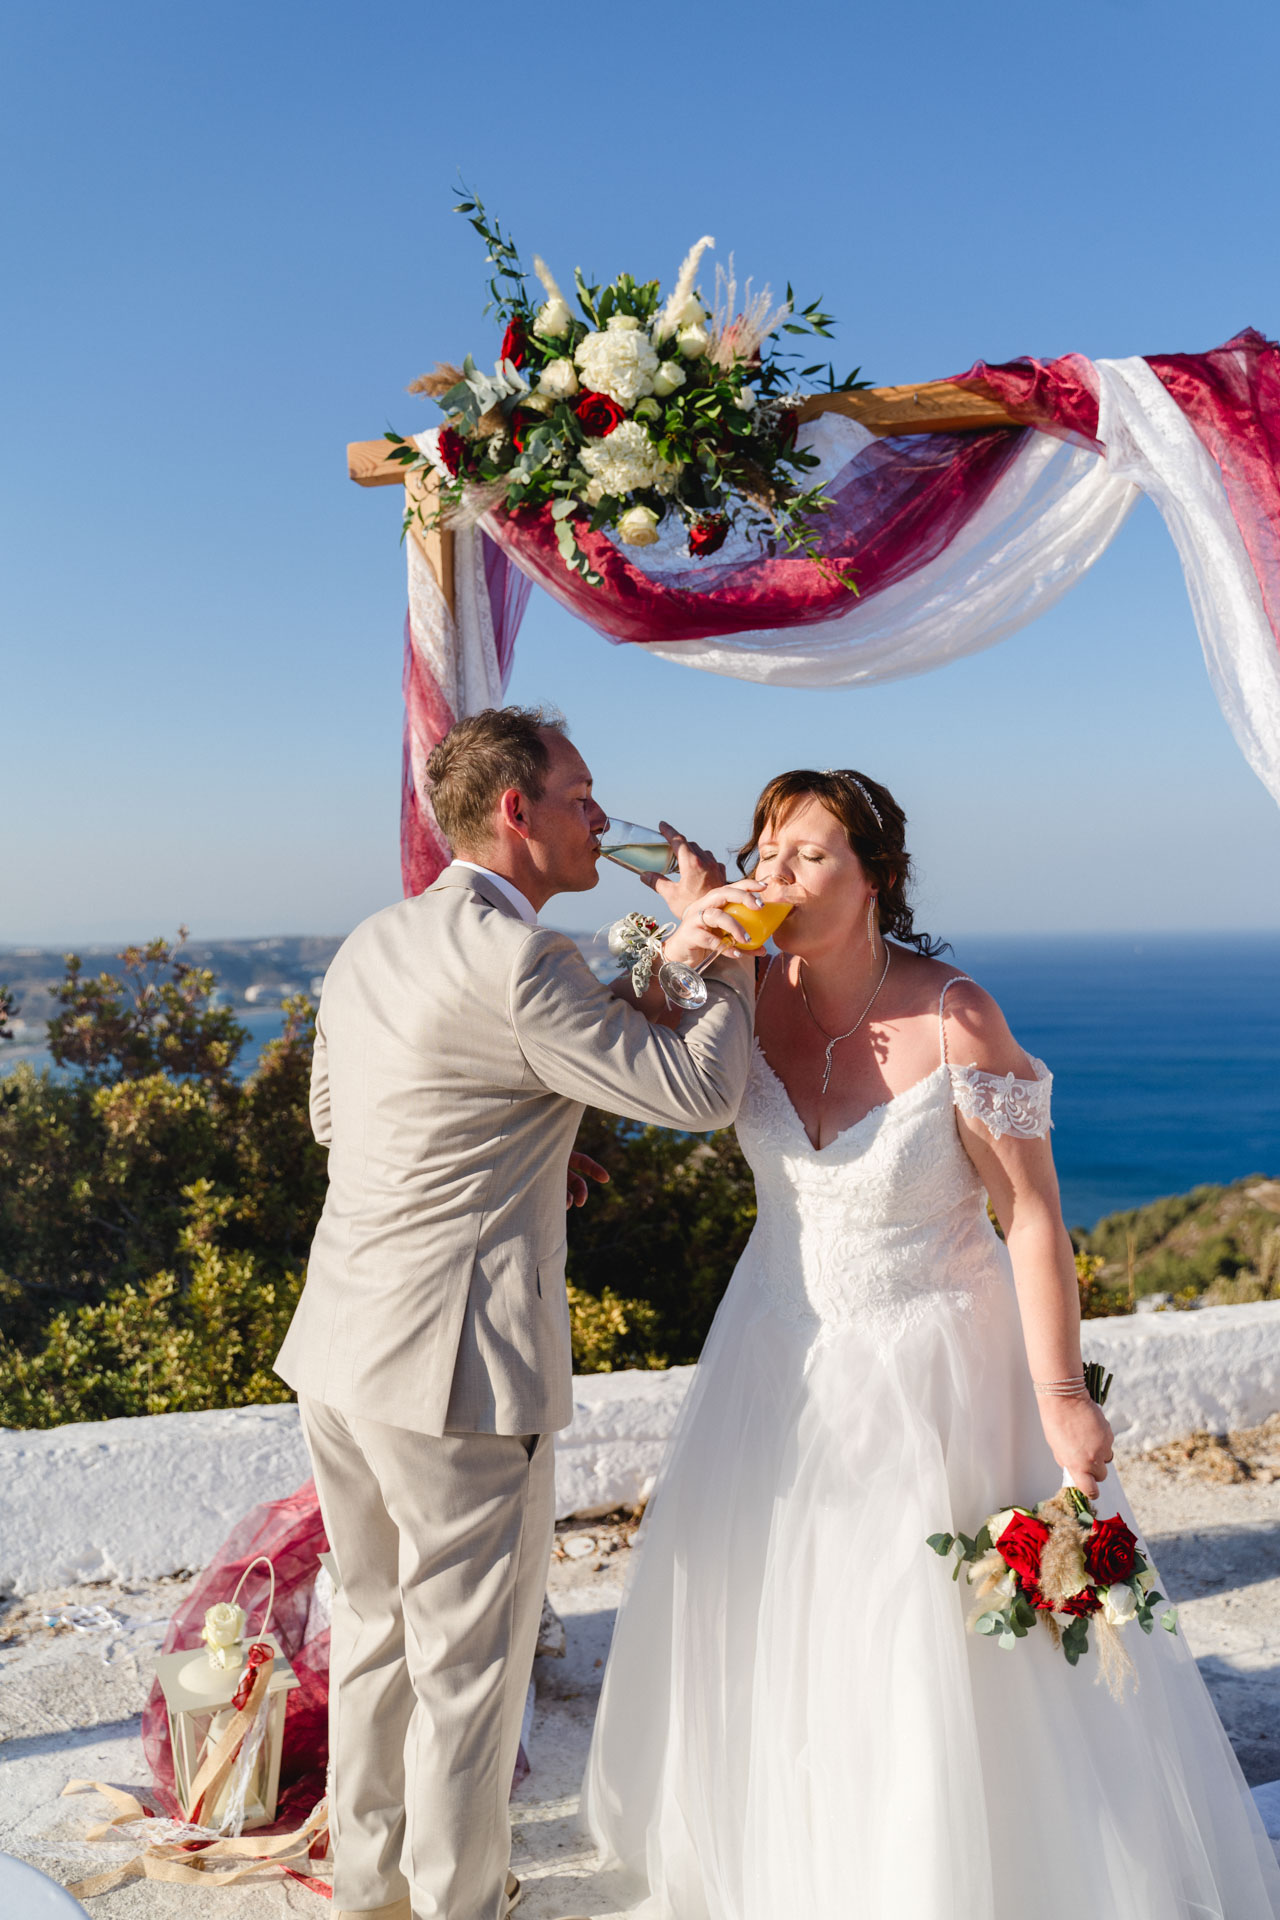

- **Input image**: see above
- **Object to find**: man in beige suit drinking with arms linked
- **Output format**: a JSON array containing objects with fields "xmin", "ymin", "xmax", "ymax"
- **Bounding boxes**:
[{"xmin": 276, "ymin": 707, "xmax": 752, "ymax": 1920}]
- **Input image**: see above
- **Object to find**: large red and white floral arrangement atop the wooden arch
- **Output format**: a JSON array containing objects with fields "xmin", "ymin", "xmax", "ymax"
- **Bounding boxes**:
[{"xmin": 386, "ymin": 190, "xmax": 867, "ymax": 591}]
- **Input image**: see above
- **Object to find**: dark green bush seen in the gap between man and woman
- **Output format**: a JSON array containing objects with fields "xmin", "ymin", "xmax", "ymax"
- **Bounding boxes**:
[{"xmin": 568, "ymin": 1112, "xmax": 756, "ymax": 1369}]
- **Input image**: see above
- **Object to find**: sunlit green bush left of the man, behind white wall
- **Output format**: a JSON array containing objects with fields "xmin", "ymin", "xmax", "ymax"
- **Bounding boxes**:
[{"xmin": 0, "ymin": 941, "xmax": 326, "ymax": 1427}]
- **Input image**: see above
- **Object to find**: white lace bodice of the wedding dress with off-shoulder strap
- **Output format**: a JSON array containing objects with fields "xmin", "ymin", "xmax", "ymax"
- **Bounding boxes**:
[{"xmin": 735, "ymin": 981, "xmax": 1052, "ymax": 1338}]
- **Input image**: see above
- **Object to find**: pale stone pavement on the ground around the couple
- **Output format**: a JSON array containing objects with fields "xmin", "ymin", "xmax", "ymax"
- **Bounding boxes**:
[{"xmin": 0, "ymin": 1457, "xmax": 1280, "ymax": 1920}]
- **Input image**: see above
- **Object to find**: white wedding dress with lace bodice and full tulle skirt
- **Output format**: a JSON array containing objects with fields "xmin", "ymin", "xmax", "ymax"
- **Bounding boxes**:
[{"xmin": 583, "ymin": 983, "xmax": 1280, "ymax": 1920}]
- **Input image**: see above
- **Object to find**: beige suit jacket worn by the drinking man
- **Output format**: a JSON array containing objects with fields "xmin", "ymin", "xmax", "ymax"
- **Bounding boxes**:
[{"xmin": 276, "ymin": 868, "xmax": 752, "ymax": 1434}]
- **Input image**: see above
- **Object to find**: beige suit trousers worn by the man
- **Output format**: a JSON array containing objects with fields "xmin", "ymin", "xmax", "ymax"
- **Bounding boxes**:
[{"xmin": 299, "ymin": 1398, "xmax": 555, "ymax": 1920}]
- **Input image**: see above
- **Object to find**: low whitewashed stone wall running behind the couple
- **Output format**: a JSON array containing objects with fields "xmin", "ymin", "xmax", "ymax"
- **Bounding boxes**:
[{"xmin": 0, "ymin": 1302, "xmax": 1280, "ymax": 1594}]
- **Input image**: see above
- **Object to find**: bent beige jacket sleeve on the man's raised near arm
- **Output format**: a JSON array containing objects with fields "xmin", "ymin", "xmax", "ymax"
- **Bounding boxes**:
[{"xmin": 509, "ymin": 927, "xmax": 754, "ymax": 1133}]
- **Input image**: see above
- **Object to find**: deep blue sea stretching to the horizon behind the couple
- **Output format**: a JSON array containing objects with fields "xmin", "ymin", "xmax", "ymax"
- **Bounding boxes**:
[{"xmin": 0, "ymin": 933, "xmax": 1280, "ymax": 1227}]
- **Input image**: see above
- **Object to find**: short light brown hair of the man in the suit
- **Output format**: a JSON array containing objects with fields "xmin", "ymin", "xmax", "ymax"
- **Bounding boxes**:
[{"xmin": 426, "ymin": 707, "xmax": 568, "ymax": 852}]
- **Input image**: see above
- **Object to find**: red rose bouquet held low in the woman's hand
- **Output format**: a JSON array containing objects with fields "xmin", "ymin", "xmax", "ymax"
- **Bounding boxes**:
[{"xmin": 927, "ymin": 1367, "xmax": 1178, "ymax": 1699}]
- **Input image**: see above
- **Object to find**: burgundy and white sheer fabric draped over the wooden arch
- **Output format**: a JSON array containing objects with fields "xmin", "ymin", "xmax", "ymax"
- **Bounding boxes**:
[{"xmin": 401, "ymin": 330, "xmax": 1280, "ymax": 893}]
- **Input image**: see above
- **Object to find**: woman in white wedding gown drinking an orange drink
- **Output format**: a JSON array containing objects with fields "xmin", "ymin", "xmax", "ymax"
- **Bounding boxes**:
[{"xmin": 585, "ymin": 772, "xmax": 1280, "ymax": 1920}]
